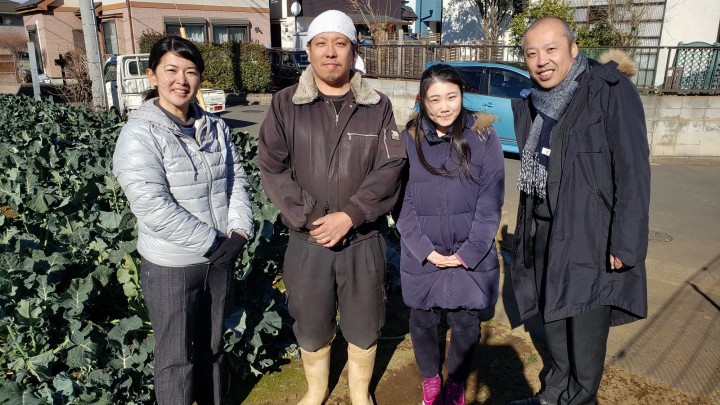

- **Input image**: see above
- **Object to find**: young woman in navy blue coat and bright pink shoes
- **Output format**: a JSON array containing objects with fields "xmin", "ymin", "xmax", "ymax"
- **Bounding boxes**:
[{"xmin": 397, "ymin": 64, "xmax": 505, "ymax": 405}]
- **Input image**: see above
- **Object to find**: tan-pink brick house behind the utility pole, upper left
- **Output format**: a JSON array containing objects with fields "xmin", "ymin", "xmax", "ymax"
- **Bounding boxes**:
[{"xmin": 16, "ymin": 0, "xmax": 270, "ymax": 82}]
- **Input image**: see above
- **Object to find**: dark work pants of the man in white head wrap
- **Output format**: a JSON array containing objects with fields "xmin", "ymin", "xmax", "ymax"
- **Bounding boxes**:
[{"xmin": 283, "ymin": 234, "xmax": 386, "ymax": 352}]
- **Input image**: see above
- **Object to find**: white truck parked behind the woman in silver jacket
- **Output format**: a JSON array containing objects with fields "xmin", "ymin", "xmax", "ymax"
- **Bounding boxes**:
[{"xmin": 103, "ymin": 53, "xmax": 225, "ymax": 120}]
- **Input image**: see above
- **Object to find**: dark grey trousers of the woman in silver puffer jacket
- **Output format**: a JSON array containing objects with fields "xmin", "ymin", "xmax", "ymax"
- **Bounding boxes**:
[{"xmin": 141, "ymin": 258, "xmax": 234, "ymax": 405}]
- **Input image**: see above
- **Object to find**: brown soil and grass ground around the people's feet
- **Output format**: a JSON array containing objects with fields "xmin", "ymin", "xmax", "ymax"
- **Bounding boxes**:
[{"xmin": 230, "ymin": 294, "xmax": 719, "ymax": 405}]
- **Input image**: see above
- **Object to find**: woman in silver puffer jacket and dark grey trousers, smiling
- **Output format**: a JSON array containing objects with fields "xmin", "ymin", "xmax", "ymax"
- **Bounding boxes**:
[{"xmin": 113, "ymin": 37, "xmax": 253, "ymax": 405}]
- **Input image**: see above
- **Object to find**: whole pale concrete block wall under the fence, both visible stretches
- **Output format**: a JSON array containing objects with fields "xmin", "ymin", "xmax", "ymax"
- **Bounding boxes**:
[{"xmin": 366, "ymin": 79, "xmax": 720, "ymax": 160}]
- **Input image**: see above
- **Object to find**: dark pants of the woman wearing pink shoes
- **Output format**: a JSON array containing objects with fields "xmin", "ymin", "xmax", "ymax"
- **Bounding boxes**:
[{"xmin": 410, "ymin": 308, "xmax": 480, "ymax": 382}]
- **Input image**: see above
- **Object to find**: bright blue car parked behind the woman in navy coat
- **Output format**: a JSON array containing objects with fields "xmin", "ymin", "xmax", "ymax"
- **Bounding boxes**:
[{"xmin": 426, "ymin": 62, "xmax": 531, "ymax": 153}]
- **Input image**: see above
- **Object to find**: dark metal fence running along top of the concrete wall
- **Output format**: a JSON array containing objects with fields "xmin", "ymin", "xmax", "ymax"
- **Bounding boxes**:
[{"xmin": 360, "ymin": 44, "xmax": 720, "ymax": 94}]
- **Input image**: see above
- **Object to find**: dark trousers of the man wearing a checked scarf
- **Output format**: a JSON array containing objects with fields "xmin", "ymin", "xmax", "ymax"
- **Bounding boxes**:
[{"xmin": 535, "ymin": 219, "xmax": 611, "ymax": 405}]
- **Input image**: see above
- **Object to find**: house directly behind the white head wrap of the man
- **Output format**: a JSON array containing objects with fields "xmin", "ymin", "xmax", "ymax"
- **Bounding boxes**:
[{"xmin": 270, "ymin": 0, "xmax": 417, "ymax": 49}]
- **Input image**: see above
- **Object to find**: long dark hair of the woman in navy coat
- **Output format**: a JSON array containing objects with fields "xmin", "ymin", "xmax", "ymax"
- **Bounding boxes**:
[{"xmin": 408, "ymin": 64, "xmax": 480, "ymax": 183}]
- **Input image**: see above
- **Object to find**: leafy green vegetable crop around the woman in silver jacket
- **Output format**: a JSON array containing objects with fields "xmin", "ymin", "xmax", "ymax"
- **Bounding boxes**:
[{"xmin": 0, "ymin": 95, "xmax": 288, "ymax": 404}]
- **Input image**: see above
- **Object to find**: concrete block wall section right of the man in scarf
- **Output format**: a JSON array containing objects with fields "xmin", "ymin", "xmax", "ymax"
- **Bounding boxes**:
[{"xmin": 640, "ymin": 95, "xmax": 720, "ymax": 159}]
